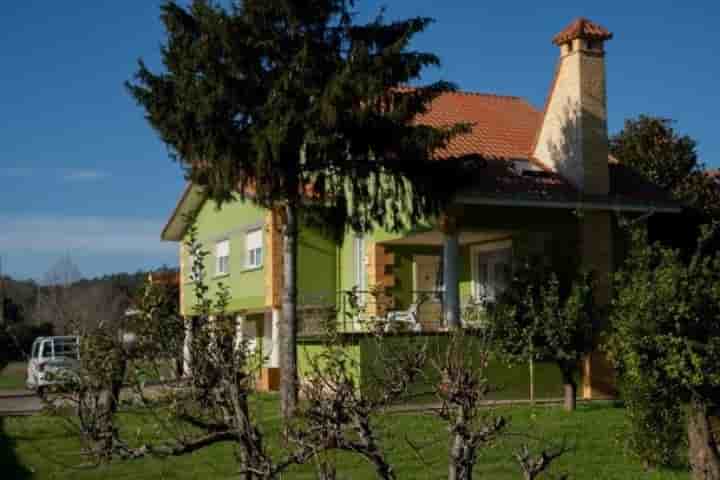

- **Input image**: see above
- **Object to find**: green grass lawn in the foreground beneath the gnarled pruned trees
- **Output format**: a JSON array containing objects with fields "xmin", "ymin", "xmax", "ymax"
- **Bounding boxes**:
[{"xmin": 0, "ymin": 397, "xmax": 689, "ymax": 480}]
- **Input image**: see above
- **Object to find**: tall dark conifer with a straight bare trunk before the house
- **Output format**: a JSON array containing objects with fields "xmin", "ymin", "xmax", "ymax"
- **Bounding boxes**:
[{"xmin": 127, "ymin": 0, "xmax": 467, "ymax": 418}]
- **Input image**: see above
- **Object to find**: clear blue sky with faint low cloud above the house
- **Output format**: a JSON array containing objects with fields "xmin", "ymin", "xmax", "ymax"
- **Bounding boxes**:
[{"xmin": 0, "ymin": 0, "xmax": 720, "ymax": 278}]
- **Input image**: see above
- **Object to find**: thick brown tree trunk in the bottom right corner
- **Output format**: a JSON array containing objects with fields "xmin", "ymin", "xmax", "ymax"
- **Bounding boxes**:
[{"xmin": 688, "ymin": 396, "xmax": 720, "ymax": 480}]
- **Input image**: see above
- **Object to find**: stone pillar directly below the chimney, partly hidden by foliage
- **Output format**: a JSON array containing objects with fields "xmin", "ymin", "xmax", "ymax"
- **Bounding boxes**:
[{"xmin": 580, "ymin": 212, "xmax": 617, "ymax": 399}]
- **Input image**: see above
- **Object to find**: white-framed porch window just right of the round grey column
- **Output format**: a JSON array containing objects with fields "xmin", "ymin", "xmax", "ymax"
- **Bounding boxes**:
[{"xmin": 472, "ymin": 242, "xmax": 512, "ymax": 301}]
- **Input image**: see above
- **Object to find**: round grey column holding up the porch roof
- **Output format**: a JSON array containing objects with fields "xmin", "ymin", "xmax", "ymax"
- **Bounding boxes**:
[{"xmin": 441, "ymin": 216, "xmax": 461, "ymax": 328}]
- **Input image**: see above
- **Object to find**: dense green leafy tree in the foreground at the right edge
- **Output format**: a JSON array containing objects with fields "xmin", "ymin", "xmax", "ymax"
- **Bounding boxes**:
[{"xmin": 607, "ymin": 228, "xmax": 720, "ymax": 480}]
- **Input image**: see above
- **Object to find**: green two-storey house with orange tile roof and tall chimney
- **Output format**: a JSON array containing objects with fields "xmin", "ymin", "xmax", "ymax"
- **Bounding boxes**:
[{"xmin": 162, "ymin": 18, "xmax": 678, "ymax": 397}]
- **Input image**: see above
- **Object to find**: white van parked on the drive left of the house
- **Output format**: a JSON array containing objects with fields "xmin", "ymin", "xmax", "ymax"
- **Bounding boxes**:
[{"xmin": 26, "ymin": 337, "xmax": 80, "ymax": 393}]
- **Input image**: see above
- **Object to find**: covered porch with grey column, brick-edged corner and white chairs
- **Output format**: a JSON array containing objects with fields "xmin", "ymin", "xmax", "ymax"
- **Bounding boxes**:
[{"xmin": 358, "ymin": 202, "xmax": 588, "ymax": 331}]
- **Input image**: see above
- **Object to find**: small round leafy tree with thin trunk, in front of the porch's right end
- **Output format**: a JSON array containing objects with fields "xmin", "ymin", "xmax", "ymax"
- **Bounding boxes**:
[{"xmin": 491, "ymin": 267, "xmax": 595, "ymax": 411}]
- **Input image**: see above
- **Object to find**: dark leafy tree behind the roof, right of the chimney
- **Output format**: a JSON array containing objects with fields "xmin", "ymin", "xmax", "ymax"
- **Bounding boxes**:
[{"xmin": 610, "ymin": 115, "xmax": 720, "ymax": 218}]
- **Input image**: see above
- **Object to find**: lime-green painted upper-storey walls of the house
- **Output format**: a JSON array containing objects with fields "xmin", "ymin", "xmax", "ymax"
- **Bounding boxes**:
[{"xmin": 181, "ymin": 201, "xmax": 578, "ymax": 316}]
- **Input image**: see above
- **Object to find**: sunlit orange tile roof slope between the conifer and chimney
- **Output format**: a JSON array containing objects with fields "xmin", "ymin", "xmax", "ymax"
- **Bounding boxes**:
[{"xmin": 418, "ymin": 92, "xmax": 542, "ymax": 160}]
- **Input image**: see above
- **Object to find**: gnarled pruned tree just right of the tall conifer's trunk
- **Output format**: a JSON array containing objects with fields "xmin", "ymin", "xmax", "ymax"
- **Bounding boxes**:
[{"xmin": 289, "ymin": 299, "xmax": 427, "ymax": 480}]
